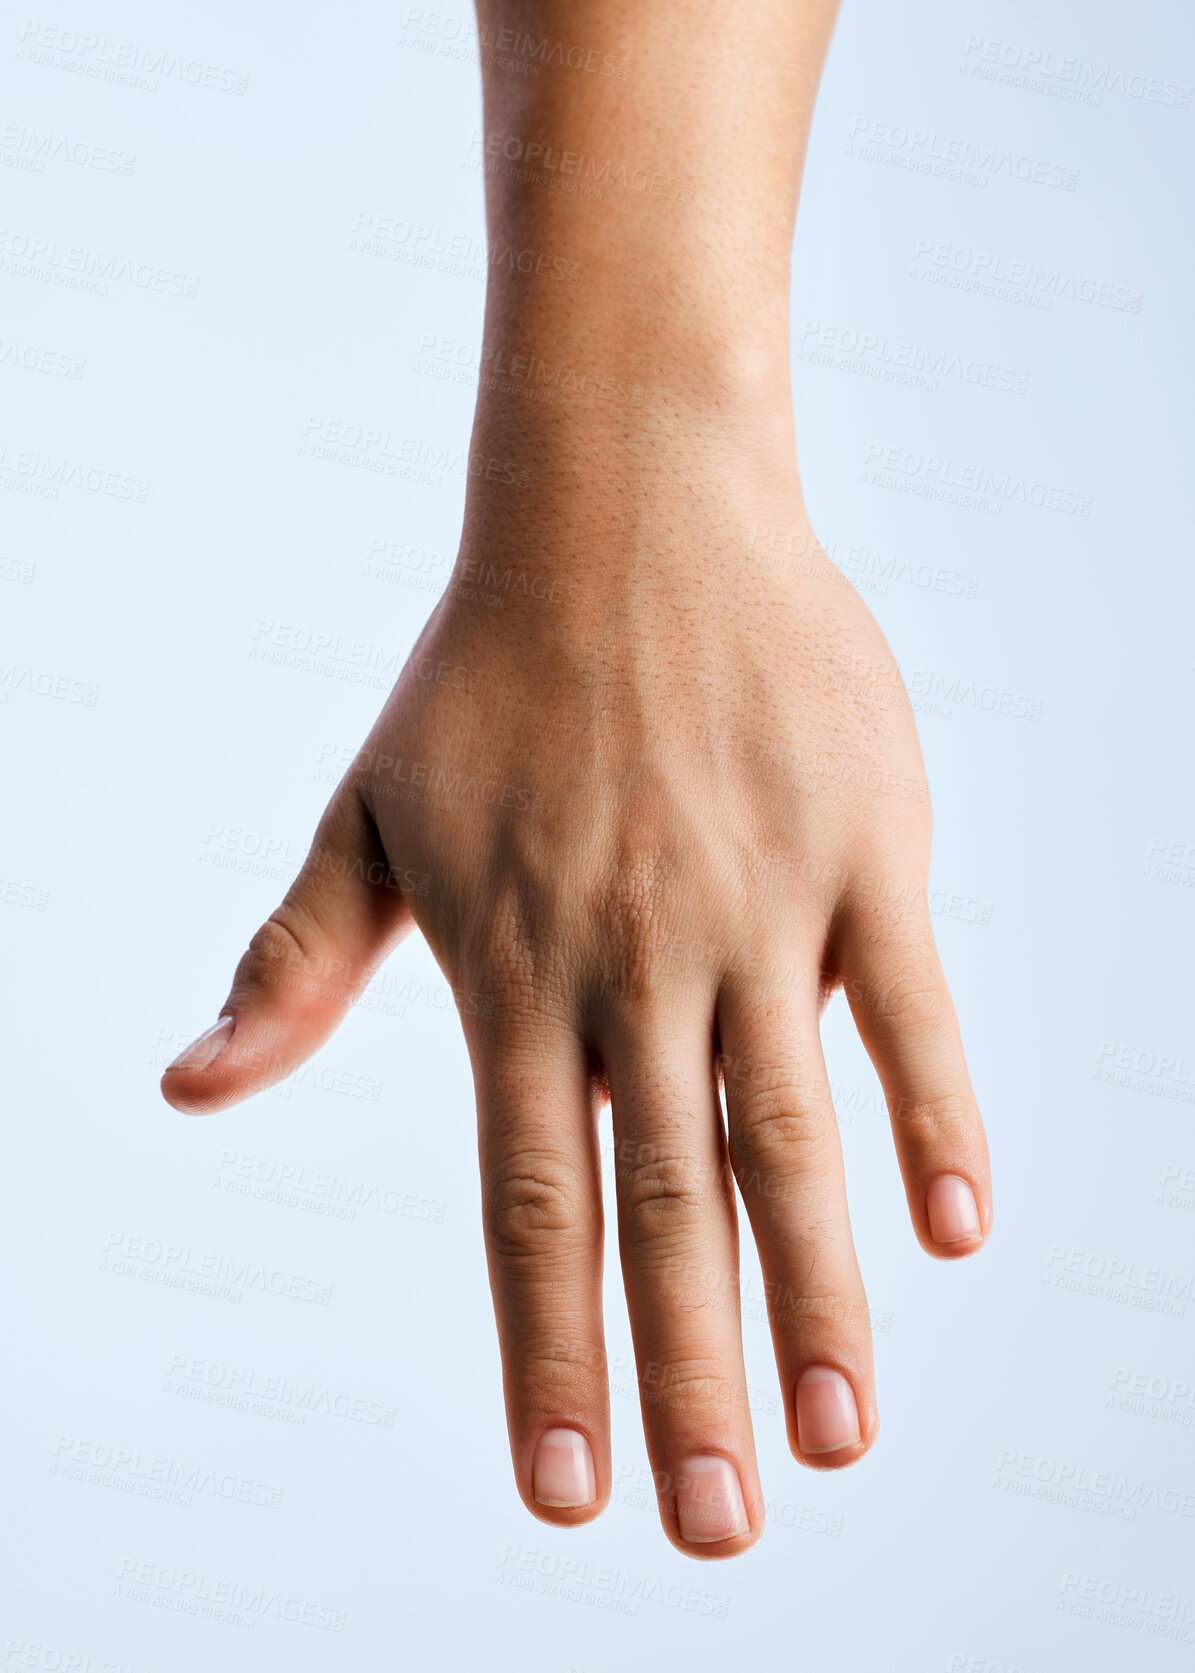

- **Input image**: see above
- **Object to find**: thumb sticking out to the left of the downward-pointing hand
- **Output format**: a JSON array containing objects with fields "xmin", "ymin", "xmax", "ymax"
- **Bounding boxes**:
[{"xmin": 162, "ymin": 786, "xmax": 413, "ymax": 1116}]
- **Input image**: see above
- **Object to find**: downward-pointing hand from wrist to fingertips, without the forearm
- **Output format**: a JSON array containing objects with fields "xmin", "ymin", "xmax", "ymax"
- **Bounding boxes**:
[{"xmin": 162, "ymin": 400, "xmax": 991, "ymax": 1556}]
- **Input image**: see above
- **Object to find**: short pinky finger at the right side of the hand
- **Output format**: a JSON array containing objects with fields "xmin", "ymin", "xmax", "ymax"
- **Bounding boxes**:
[{"xmin": 840, "ymin": 908, "xmax": 992, "ymax": 1260}]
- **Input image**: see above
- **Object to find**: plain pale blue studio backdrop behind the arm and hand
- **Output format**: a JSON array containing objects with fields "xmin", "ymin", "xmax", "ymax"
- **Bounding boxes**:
[{"xmin": 0, "ymin": 0, "xmax": 1195, "ymax": 1673}]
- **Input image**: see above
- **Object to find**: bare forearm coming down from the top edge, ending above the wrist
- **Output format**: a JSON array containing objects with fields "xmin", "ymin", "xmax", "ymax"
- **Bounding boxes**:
[{"xmin": 479, "ymin": 0, "xmax": 837, "ymax": 390}]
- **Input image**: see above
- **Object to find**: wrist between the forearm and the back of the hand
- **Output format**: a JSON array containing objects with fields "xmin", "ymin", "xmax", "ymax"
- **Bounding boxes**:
[{"xmin": 452, "ymin": 391, "xmax": 817, "ymax": 629}]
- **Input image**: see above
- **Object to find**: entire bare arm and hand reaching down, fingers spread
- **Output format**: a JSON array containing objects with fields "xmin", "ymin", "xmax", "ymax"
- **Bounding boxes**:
[{"xmin": 162, "ymin": 0, "xmax": 991, "ymax": 1558}]
